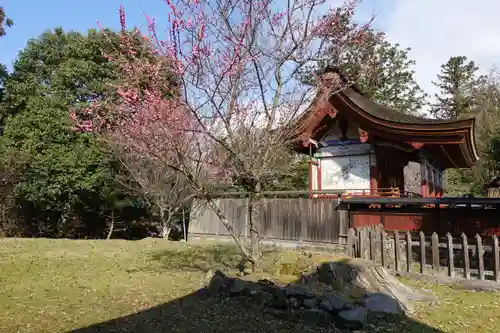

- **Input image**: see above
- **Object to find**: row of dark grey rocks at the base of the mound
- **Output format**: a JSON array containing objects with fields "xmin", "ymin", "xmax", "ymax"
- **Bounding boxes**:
[{"xmin": 207, "ymin": 271, "xmax": 403, "ymax": 329}]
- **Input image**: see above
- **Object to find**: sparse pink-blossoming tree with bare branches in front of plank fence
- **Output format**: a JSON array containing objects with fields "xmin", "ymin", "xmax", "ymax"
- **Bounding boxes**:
[{"xmin": 70, "ymin": 0, "xmax": 376, "ymax": 263}]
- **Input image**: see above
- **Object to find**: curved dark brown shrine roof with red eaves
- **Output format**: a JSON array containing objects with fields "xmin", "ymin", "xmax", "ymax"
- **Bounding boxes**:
[{"xmin": 298, "ymin": 68, "xmax": 479, "ymax": 169}]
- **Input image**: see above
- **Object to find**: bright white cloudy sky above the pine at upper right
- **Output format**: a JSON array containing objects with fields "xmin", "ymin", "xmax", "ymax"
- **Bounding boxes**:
[{"xmin": 384, "ymin": 0, "xmax": 500, "ymax": 99}]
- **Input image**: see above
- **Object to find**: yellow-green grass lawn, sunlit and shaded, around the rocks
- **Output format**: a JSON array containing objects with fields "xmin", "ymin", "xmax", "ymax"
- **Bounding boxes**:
[{"xmin": 0, "ymin": 239, "xmax": 500, "ymax": 333}]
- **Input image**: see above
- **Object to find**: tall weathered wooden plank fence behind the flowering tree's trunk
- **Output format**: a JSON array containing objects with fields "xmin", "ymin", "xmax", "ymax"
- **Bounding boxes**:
[{"xmin": 188, "ymin": 198, "xmax": 349, "ymax": 244}]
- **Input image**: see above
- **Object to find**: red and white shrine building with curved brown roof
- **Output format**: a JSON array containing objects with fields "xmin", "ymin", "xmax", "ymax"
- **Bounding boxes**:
[{"xmin": 296, "ymin": 69, "xmax": 479, "ymax": 197}]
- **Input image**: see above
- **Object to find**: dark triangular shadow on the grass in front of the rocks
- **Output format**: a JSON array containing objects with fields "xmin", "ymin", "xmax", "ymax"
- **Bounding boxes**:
[{"xmin": 67, "ymin": 260, "xmax": 442, "ymax": 333}]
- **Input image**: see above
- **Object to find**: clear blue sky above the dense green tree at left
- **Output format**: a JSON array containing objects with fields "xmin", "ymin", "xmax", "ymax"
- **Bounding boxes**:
[{"xmin": 0, "ymin": 0, "xmax": 390, "ymax": 68}]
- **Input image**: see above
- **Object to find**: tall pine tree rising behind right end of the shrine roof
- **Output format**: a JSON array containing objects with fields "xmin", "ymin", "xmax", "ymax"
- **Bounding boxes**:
[{"xmin": 430, "ymin": 56, "xmax": 484, "ymax": 119}]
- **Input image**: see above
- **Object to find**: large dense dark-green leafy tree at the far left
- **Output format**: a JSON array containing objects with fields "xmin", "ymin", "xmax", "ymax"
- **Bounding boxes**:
[{"xmin": 0, "ymin": 28, "xmax": 145, "ymax": 237}]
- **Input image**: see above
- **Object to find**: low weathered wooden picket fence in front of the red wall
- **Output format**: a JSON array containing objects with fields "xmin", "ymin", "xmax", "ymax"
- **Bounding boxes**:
[{"xmin": 347, "ymin": 226, "xmax": 500, "ymax": 282}]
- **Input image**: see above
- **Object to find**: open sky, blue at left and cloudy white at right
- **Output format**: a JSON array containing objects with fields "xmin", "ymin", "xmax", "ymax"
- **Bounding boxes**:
[{"xmin": 0, "ymin": 0, "xmax": 500, "ymax": 97}]
